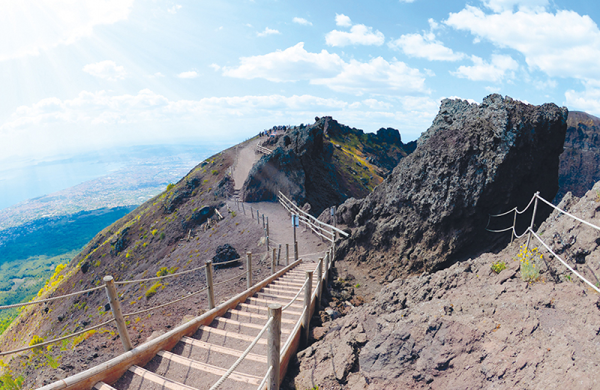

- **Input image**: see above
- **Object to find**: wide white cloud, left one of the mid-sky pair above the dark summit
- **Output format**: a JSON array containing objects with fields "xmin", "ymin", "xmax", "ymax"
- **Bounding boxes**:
[{"xmin": 223, "ymin": 42, "xmax": 345, "ymax": 82}]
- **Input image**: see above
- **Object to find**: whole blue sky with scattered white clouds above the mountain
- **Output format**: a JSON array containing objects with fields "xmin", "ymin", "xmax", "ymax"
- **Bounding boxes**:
[{"xmin": 0, "ymin": 0, "xmax": 600, "ymax": 167}]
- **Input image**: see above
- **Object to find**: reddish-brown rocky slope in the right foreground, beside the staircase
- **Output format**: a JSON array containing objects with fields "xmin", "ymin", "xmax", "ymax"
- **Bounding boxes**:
[{"xmin": 286, "ymin": 184, "xmax": 600, "ymax": 389}]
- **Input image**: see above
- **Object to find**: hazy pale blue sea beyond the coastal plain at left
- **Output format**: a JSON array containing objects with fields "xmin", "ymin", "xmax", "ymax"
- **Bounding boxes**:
[{"xmin": 0, "ymin": 145, "xmax": 216, "ymax": 210}]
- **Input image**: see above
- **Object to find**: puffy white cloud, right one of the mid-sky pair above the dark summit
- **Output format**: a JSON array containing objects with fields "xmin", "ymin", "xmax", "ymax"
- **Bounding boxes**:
[{"xmin": 311, "ymin": 57, "xmax": 429, "ymax": 96}]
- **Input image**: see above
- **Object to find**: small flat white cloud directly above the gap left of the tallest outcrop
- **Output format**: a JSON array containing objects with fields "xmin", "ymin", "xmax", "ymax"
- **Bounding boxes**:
[{"xmin": 388, "ymin": 33, "xmax": 465, "ymax": 61}]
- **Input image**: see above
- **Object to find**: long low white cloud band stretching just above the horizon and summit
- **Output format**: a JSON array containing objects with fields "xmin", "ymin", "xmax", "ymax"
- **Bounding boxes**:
[{"xmin": 0, "ymin": 89, "xmax": 438, "ymax": 158}]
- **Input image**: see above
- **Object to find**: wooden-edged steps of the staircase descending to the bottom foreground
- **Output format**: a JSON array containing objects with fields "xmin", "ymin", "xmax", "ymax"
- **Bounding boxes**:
[{"xmin": 94, "ymin": 263, "xmax": 316, "ymax": 390}]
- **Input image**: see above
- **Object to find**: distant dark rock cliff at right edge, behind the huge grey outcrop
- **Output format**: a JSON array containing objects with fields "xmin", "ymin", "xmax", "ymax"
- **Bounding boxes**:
[{"xmin": 555, "ymin": 111, "xmax": 600, "ymax": 202}]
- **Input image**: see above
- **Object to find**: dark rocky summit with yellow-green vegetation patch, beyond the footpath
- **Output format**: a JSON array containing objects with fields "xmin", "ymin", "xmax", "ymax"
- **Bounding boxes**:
[{"xmin": 242, "ymin": 116, "xmax": 416, "ymax": 216}]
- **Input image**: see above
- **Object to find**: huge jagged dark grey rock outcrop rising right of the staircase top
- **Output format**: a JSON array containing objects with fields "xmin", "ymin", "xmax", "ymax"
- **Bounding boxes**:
[{"xmin": 337, "ymin": 94, "xmax": 567, "ymax": 281}]
